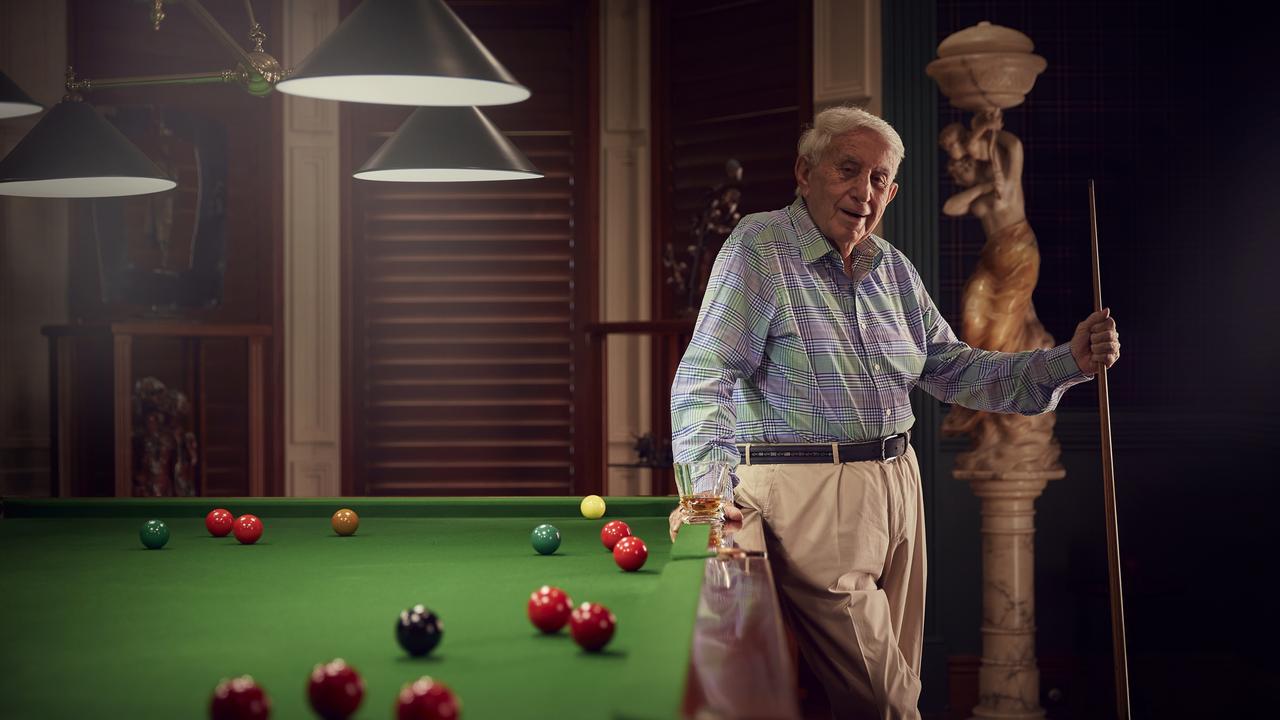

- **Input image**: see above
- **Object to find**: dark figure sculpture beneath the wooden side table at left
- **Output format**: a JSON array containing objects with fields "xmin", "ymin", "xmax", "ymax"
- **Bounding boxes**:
[{"xmin": 133, "ymin": 378, "xmax": 200, "ymax": 497}]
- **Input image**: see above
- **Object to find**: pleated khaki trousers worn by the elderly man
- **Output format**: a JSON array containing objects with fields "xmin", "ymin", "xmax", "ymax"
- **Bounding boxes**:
[{"xmin": 735, "ymin": 447, "xmax": 925, "ymax": 720}]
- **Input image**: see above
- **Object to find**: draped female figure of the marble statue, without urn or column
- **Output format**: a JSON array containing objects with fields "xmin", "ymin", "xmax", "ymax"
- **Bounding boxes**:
[{"xmin": 938, "ymin": 108, "xmax": 1061, "ymax": 473}]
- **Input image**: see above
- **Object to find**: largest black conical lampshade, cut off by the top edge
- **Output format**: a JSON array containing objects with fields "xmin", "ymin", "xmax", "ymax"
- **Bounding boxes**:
[{"xmin": 275, "ymin": 0, "xmax": 530, "ymax": 105}]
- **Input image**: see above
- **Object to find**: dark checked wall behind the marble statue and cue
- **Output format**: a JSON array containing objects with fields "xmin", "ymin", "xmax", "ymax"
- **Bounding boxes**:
[{"xmin": 921, "ymin": 0, "xmax": 1280, "ymax": 717}]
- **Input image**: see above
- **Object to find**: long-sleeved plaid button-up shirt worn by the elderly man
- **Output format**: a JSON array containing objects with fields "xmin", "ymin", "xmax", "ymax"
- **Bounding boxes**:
[{"xmin": 671, "ymin": 199, "xmax": 1089, "ymax": 466}]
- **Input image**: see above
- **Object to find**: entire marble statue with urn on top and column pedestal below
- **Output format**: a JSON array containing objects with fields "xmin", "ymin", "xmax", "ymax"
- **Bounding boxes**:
[{"xmin": 925, "ymin": 22, "xmax": 1065, "ymax": 720}]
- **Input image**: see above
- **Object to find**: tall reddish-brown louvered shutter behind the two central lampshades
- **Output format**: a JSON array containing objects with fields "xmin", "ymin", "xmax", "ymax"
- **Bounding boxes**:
[{"xmin": 343, "ymin": 0, "xmax": 596, "ymax": 495}]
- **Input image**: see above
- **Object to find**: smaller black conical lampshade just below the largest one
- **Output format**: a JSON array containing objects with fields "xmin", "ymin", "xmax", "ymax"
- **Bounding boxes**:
[{"xmin": 356, "ymin": 108, "xmax": 543, "ymax": 182}]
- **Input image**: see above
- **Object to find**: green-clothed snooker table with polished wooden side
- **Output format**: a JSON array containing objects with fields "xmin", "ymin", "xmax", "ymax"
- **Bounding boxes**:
[{"xmin": 0, "ymin": 497, "xmax": 796, "ymax": 720}]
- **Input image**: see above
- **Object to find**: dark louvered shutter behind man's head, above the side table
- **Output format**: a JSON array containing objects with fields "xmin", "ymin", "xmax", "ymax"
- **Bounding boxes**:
[{"xmin": 653, "ymin": 0, "xmax": 813, "ymax": 319}]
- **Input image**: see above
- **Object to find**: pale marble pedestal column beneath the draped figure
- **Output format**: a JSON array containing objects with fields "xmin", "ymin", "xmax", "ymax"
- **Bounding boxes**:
[{"xmin": 954, "ymin": 469, "xmax": 1066, "ymax": 720}]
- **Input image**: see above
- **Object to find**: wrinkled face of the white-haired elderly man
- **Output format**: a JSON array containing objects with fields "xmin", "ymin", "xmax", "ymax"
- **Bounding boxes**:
[{"xmin": 796, "ymin": 128, "xmax": 897, "ymax": 243}]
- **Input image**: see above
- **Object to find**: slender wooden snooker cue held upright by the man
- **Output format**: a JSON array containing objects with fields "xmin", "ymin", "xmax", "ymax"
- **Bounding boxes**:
[{"xmin": 1089, "ymin": 179, "xmax": 1129, "ymax": 720}]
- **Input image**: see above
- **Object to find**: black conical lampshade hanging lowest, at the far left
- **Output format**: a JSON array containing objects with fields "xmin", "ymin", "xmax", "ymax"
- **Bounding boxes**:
[{"xmin": 0, "ymin": 100, "xmax": 178, "ymax": 197}]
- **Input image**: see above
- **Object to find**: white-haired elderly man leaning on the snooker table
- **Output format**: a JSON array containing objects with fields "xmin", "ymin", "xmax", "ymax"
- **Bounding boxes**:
[{"xmin": 671, "ymin": 108, "xmax": 1120, "ymax": 719}]
